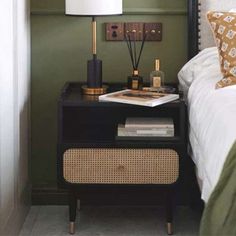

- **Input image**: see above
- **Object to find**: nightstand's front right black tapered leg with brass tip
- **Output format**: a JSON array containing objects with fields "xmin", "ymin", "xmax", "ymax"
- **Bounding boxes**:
[{"xmin": 166, "ymin": 187, "xmax": 173, "ymax": 235}]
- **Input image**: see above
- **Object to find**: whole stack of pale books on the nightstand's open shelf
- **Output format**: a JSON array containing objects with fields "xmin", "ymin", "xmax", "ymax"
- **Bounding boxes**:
[{"xmin": 118, "ymin": 117, "xmax": 175, "ymax": 137}]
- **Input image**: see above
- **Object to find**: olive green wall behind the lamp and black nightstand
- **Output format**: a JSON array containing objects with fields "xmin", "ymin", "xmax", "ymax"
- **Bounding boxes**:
[{"xmin": 31, "ymin": 0, "xmax": 187, "ymax": 187}]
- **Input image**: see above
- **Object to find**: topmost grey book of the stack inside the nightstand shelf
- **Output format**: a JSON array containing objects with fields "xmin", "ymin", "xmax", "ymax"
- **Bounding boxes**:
[{"xmin": 125, "ymin": 117, "xmax": 174, "ymax": 129}]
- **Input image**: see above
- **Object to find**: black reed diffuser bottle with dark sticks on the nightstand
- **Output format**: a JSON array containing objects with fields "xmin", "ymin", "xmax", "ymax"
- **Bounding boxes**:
[{"xmin": 125, "ymin": 34, "xmax": 146, "ymax": 90}]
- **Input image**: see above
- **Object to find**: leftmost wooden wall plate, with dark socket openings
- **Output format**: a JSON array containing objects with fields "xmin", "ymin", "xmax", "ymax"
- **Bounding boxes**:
[{"xmin": 106, "ymin": 22, "xmax": 124, "ymax": 41}]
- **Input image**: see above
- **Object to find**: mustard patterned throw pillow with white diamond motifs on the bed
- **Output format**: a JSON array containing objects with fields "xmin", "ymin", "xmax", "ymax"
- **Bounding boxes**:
[{"xmin": 207, "ymin": 12, "xmax": 236, "ymax": 88}]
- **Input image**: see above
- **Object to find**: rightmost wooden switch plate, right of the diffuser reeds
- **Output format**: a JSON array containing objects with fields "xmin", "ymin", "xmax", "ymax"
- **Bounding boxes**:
[{"xmin": 144, "ymin": 23, "xmax": 162, "ymax": 41}]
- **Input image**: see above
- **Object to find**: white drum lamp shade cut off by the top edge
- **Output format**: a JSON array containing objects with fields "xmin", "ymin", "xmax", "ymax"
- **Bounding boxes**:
[{"xmin": 66, "ymin": 0, "xmax": 123, "ymax": 16}]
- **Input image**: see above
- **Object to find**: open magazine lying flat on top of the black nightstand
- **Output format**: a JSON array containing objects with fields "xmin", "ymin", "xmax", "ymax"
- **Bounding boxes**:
[{"xmin": 99, "ymin": 89, "xmax": 179, "ymax": 107}]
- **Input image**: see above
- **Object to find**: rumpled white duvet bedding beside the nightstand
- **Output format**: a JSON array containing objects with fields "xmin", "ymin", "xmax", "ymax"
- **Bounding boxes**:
[{"xmin": 179, "ymin": 48, "xmax": 236, "ymax": 202}]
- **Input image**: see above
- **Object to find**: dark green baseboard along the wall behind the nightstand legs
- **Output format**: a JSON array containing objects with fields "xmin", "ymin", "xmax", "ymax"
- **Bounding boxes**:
[{"xmin": 32, "ymin": 184, "xmax": 197, "ymax": 206}]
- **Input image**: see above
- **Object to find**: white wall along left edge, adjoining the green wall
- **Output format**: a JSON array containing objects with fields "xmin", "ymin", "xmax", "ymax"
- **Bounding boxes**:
[{"xmin": 0, "ymin": 0, "xmax": 30, "ymax": 233}]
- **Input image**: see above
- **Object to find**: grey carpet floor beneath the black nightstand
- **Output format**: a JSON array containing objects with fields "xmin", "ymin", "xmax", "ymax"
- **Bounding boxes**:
[{"xmin": 20, "ymin": 206, "xmax": 201, "ymax": 236}]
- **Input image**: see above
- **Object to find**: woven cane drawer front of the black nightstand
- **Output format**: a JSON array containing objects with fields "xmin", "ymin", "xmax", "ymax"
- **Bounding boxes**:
[{"xmin": 63, "ymin": 148, "xmax": 179, "ymax": 184}]
